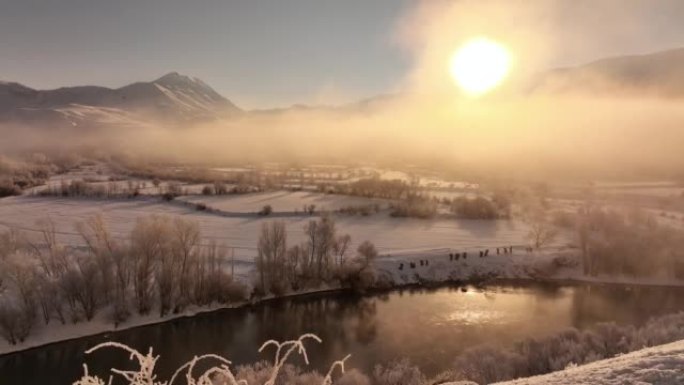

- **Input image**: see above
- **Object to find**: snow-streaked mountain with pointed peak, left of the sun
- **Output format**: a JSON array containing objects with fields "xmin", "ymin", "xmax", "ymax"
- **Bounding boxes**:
[{"xmin": 0, "ymin": 72, "xmax": 242, "ymax": 126}]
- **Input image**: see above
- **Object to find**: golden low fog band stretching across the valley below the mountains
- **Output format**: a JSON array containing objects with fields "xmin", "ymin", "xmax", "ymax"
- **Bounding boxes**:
[{"xmin": 0, "ymin": 95, "xmax": 684, "ymax": 182}]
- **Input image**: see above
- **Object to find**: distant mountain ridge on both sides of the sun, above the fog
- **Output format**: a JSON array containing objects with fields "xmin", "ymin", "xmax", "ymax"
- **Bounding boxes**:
[{"xmin": 0, "ymin": 47, "xmax": 684, "ymax": 127}]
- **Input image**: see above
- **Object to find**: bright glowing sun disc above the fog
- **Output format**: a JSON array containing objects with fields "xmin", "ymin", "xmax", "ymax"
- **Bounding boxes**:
[{"xmin": 450, "ymin": 37, "xmax": 511, "ymax": 96}]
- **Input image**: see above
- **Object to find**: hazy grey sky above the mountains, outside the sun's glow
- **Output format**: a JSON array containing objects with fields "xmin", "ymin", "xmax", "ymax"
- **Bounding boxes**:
[{"xmin": 0, "ymin": 0, "xmax": 684, "ymax": 108}]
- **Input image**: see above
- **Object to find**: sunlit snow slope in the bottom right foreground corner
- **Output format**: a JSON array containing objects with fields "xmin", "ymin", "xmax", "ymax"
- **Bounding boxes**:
[{"xmin": 500, "ymin": 340, "xmax": 684, "ymax": 385}]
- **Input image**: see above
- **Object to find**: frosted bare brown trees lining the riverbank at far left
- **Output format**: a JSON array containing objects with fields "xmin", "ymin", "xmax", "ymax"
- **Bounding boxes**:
[{"xmin": 0, "ymin": 216, "xmax": 247, "ymax": 344}]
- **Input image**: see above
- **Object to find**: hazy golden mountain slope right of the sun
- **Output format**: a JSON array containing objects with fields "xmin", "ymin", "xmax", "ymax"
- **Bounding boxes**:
[{"xmin": 532, "ymin": 48, "xmax": 684, "ymax": 98}]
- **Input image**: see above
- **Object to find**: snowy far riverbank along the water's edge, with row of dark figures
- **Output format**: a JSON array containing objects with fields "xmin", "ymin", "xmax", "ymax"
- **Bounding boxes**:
[{"xmin": 0, "ymin": 244, "xmax": 684, "ymax": 355}]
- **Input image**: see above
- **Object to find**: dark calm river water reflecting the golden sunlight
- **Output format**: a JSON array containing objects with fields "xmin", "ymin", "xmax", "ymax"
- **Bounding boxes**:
[{"xmin": 0, "ymin": 284, "xmax": 684, "ymax": 385}]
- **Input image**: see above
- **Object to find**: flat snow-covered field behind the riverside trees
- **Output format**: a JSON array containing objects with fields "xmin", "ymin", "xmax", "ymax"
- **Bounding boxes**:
[{"xmin": 0, "ymin": 195, "xmax": 540, "ymax": 260}]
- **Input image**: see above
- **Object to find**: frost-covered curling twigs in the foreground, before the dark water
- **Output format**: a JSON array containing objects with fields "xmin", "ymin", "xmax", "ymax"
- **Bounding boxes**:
[{"xmin": 74, "ymin": 334, "xmax": 352, "ymax": 385}]
